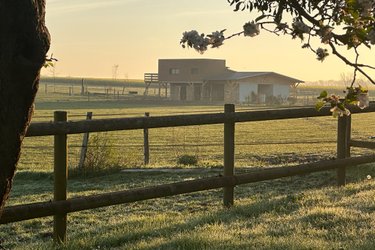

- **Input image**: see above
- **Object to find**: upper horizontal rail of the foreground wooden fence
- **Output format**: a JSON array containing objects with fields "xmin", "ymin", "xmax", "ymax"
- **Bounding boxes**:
[{"xmin": 26, "ymin": 103, "xmax": 375, "ymax": 137}]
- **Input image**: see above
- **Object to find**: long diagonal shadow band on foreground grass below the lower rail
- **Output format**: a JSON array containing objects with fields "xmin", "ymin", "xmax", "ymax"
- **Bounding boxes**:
[{"xmin": 68, "ymin": 196, "xmax": 299, "ymax": 249}]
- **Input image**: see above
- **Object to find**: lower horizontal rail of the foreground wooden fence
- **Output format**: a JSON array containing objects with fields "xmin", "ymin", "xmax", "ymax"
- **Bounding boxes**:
[{"xmin": 0, "ymin": 155, "xmax": 375, "ymax": 224}]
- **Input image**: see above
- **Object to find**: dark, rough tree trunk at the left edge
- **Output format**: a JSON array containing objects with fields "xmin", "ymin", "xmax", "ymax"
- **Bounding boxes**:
[{"xmin": 0, "ymin": 0, "xmax": 50, "ymax": 217}]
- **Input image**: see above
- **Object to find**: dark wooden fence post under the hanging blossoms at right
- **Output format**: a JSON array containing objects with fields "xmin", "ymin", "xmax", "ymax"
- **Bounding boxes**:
[{"xmin": 337, "ymin": 115, "xmax": 351, "ymax": 186}]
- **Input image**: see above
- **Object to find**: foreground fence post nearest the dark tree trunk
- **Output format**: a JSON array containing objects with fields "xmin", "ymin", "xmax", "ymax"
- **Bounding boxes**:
[{"xmin": 53, "ymin": 111, "xmax": 68, "ymax": 243}]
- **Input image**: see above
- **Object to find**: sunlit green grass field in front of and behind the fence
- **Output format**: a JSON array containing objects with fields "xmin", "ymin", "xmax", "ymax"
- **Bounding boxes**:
[{"xmin": 0, "ymin": 85, "xmax": 375, "ymax": 249}]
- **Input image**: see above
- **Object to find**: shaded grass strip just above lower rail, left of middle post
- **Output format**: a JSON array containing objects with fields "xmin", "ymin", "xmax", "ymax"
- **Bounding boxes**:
[{"xmin": 11, "ymin": 168, "xmax": 217, "ymax": 199}]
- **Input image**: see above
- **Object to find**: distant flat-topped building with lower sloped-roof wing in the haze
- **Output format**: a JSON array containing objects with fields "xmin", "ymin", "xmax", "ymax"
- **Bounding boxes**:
[{"xmin": 158, "ymin": 59, "xmax": 303, "ymax": 103}]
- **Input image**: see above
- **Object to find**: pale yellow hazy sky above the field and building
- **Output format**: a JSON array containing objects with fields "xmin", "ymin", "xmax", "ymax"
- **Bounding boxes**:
[{"xmin": 43, "ymin": 0, "xmax": 375, "ymax": 81}]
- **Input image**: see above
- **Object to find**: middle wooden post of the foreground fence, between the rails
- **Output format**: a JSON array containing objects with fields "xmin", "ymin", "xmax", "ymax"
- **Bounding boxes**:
[{"xmin": 223, "ymin": 104, "xmax": 235, "ymax": 207}]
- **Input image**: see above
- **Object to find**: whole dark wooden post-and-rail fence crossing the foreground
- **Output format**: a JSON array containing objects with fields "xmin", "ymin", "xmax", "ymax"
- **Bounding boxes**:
[{"xmin": 0, "ymin": 103, "xmax": 375, "ymax": 242}]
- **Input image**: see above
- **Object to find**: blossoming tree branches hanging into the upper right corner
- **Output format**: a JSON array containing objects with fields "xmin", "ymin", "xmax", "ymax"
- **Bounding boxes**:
[{"xmin": 181, "ymin": 0, "xmax": 375, "ymax": 116}]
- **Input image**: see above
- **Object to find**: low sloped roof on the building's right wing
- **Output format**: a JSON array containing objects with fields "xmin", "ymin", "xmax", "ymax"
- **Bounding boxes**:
[{"xmin": 205, "ymin": 69, "xmax": 304, "ymax": 83}]
